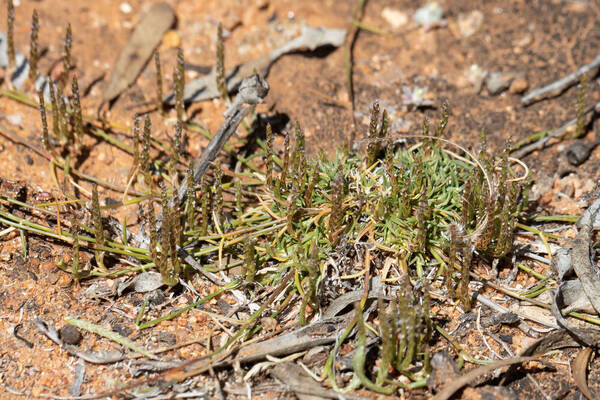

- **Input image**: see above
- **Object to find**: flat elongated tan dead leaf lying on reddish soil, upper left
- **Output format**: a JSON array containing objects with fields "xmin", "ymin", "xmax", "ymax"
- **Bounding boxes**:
[{"xmin": 104, "ymin": 3, "xmax": 175, "ymax": 101}]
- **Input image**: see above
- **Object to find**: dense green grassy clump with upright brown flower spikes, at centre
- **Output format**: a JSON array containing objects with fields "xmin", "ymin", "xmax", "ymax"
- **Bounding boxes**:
[{"xmin": 22, "ymin": 90, "xmax": 524, "ymax": 393}]
